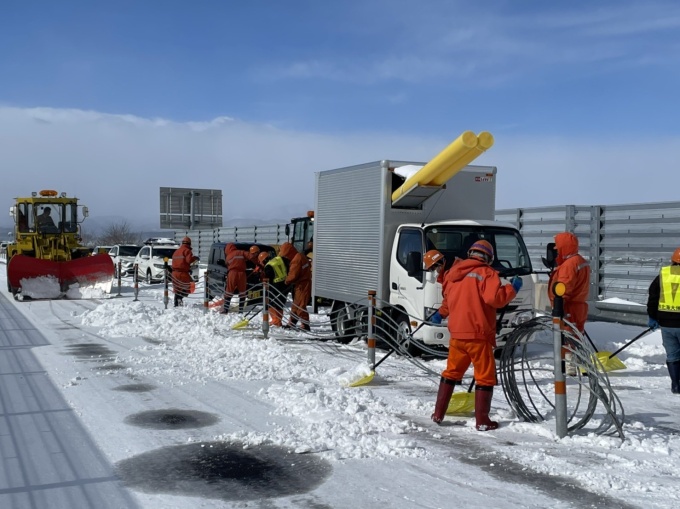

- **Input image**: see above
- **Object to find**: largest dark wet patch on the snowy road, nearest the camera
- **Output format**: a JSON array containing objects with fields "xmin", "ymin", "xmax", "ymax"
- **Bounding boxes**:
[{"xmin": 116, "ymin": 442, "xmax": 332, "ymax": 501}]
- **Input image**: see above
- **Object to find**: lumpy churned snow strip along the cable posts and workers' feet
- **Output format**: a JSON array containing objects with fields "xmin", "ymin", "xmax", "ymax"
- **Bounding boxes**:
[{"xmin": 71, "ymin": 292, "xmax": 680, "ymax": 507}]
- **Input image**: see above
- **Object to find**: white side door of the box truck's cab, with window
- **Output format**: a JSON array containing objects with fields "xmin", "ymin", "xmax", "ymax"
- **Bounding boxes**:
[{"xmin": 390, "ymin": 228, "xmax": 424, "ymax": 317}]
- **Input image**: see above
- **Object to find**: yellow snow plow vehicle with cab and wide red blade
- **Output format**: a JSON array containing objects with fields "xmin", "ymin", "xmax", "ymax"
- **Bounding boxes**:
[{"xmin": 7, "ymin": 190, "xmax": 113, "ymax": 297}]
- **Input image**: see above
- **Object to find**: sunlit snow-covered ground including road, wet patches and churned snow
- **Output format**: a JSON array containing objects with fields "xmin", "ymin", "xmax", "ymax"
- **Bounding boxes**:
[{"xmin": 0, "ymin": 271, "xmax": 680, "ymax": 509}]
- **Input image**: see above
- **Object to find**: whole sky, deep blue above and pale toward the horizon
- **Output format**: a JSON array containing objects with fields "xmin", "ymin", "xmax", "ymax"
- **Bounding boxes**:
[{"xmin": 0, "ymin": 0, "xmax": 680, "ymax": 226}]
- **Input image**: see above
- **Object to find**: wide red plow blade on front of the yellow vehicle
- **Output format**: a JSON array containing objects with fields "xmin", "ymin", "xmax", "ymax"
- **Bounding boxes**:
[{"xmin": 7, "ymin": 254, "xmax": 113, "ymax": 293}]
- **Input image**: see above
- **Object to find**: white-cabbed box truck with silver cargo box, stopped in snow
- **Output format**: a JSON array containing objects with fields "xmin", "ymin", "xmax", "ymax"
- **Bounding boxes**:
[{"xmin": 312, "ymin": 160, "xmax": 533, "ymax": 353}]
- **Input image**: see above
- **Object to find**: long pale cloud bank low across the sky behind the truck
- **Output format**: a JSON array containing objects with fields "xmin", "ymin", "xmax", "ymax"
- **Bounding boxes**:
[{"xmin": 0, "ymin": 107, "xmax": 680, "ymax": 230}]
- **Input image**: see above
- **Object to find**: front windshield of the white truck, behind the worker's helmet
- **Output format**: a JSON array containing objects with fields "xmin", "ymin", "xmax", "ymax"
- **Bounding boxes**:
[{"xmin": 425, "ymin": 225, "xmax": 532, "ymax": 277}]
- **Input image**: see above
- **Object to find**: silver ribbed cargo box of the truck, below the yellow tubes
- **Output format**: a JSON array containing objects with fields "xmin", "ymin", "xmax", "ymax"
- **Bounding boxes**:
[{"xmin": 313, "ymin": 160, "xmax": 496, "ymax": 302}]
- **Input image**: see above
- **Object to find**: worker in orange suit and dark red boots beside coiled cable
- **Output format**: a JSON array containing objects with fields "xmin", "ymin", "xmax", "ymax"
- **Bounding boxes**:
[{"xmin": 432, "ymin": 240, "xmax": 522, "ymax": 431}]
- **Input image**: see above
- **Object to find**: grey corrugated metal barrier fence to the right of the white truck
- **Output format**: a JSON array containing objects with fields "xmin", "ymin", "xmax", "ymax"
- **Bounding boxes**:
[{"xmin": 496, "ymin": 202, "xmax": 680, "ymax": 324}]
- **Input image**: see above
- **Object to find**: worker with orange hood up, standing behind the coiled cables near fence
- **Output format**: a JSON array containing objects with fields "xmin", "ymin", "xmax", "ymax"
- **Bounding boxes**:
[{"xmin": 548, "ymin": 232, "xmax": 590, "ymax": 332}]
